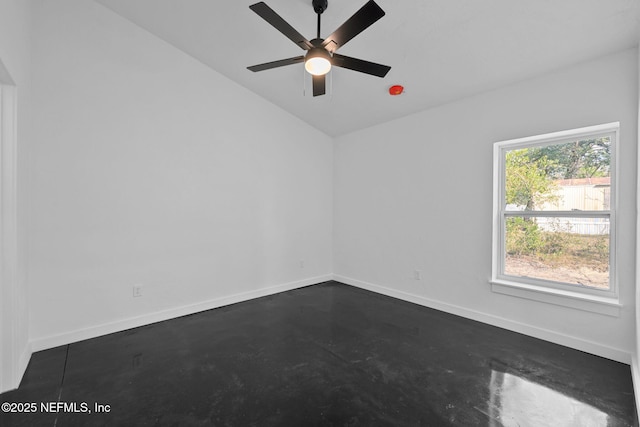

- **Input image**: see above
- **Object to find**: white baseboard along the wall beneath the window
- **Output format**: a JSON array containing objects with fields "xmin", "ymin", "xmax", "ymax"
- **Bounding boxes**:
[{"xmin": 333, "ymin": 274, "xmax": 640, "ymax": 364}]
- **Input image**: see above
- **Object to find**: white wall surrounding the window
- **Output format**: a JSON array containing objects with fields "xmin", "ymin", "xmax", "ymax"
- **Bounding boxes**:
[{"xmin": 334, "ymin": 49, "xmax": 638, "ymax": 363}]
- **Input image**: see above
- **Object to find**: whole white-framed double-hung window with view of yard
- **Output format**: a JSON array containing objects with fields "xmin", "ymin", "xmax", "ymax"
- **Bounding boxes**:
[{"xmin": 492, "ymin": 123, "xmax": 619, "ymax": 314}]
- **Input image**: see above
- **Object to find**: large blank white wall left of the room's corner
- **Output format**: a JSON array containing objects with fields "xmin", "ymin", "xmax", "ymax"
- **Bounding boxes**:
[{"xmin": 29, "ymin": 0, "xmax": 332, "ymax": 349}]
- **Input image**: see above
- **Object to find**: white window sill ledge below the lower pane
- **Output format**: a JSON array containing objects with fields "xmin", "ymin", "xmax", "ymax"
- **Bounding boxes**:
[{"xmin": 491, "ymin": 279, "xmax": 622, "ymax": 317}]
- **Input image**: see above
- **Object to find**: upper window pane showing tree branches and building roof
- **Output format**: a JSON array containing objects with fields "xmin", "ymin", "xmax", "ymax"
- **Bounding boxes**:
[{"xmin": 504, "ymin": 136, "xmax": 611, "ymax": 211}]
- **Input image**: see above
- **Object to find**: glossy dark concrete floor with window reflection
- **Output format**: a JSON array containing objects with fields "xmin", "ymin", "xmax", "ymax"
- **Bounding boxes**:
[{"xmin": 0, "ymin": 282, "xmax": 638, "ymax": 427}]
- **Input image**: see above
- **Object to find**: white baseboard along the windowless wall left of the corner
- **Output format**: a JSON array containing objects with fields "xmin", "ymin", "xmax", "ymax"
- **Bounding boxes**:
[{"xmin": 27, "ymin": 274, "xmax": 332, "ymax": 352}]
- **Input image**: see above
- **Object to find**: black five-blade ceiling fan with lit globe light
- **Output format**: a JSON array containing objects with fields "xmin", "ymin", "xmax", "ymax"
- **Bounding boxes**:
[{"xmin": 247, "ymin": 0, "xmax": 391, "ymax": 96}]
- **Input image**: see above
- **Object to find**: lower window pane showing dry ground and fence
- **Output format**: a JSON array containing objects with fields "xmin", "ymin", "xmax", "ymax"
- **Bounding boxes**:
[{"xmin": 504, "ymin": 216, "xmax": 609, "ymax": 289}]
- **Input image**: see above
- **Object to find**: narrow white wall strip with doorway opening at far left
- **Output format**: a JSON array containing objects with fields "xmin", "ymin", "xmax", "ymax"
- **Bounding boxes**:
[{"xmin": 0, "ymin": 0, "xmax": 31, "ymax": 392}]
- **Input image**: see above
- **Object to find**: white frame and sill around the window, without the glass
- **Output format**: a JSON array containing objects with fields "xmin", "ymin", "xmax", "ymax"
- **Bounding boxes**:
[{"xmin": 491, "ymin": 122, "xmax": 621, "ymax": 316}]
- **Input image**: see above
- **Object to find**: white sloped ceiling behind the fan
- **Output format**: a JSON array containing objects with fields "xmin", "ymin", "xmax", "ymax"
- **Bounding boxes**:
[{"xmin": 97, "ymin": 0, "xmax": 640, "ymax": 136}]
